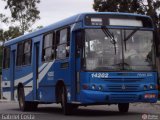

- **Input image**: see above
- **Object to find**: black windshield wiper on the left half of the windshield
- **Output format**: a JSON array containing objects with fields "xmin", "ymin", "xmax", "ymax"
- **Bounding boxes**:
[{"xmin": 101, "ymin": 26, "xmax": 117, "ymax": 54}]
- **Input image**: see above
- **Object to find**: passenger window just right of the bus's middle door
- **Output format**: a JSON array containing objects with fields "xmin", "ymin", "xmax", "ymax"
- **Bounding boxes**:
[{"xmin": 42, "ymin": 33, "xmax": 54, "ymax": 61}]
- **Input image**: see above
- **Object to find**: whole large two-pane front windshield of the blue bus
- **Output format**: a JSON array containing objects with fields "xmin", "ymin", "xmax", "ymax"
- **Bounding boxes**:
[{"xmin": 83, "ymin": 28, "xmax": 154, "ymax": 71}]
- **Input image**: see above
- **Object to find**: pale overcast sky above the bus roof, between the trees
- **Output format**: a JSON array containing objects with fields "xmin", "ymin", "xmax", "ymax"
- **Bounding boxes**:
[{"xmin": 0, "ymin": 0, "xmax": 94, "ymax": 28}]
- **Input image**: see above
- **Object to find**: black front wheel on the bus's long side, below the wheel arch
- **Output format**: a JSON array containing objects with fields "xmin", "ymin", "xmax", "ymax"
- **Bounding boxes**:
[{"xmin": 61, "ymin": 86, "xmax": 73, "ymax": 115}]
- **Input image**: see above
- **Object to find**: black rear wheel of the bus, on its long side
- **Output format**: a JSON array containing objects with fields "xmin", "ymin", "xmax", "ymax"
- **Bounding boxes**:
[{"xmin": 18, "ymin": 87, "xmax": 38, "ymax": 111}]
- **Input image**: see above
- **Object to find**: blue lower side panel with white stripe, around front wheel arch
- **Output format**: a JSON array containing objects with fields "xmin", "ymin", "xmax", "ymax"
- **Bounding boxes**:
[{"xmin": 38, "ymin": 60, "xmax": 71, "ymax": 102}]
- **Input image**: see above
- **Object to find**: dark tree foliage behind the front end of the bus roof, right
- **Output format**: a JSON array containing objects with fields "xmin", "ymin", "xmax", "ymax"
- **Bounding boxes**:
[{"xmin": 93, "ymin": 0, "xmax": 160, "ymax": 26}]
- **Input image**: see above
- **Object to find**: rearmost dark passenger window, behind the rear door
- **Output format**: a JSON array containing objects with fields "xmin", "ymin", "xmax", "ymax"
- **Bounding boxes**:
[{"xmin": 3, "ymin": 47, "xmax": 10, "ymax": 69}]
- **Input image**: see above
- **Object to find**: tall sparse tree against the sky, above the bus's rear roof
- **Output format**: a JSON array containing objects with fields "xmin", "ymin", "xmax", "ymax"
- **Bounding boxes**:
[{"xmin": 3, "ymin": 0, "xmax": 40, "ymax": 34}]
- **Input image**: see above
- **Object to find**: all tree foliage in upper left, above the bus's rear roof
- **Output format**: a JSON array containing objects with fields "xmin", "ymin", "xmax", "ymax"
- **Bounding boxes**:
[{"xmin": 0, "ymin": 0, "xmax": 40, "ymax": 41}]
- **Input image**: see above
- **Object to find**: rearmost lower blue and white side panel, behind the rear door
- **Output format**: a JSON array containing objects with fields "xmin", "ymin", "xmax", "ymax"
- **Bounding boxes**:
[{"xmin": 2, "ymin": 69, "xmax": 11, "ymax": 100}]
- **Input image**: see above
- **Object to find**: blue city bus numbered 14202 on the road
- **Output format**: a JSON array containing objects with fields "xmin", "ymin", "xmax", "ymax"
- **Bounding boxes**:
[{"xmin": 2, "ymin": 12, "xmax": 158, "ymax": 115}]
